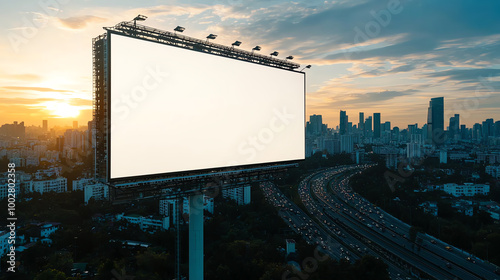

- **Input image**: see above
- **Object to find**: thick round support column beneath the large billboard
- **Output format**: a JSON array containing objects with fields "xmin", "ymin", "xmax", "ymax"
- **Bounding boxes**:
[{"xmin": 189, "ymin": 193, "xmax": 203, "ymax": 280}]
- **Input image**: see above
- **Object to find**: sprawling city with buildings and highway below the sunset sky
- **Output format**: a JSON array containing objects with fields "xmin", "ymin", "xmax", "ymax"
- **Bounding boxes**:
[{"xmin": 0, "ymin": 94, "xmax": 500, "ymax": 279}]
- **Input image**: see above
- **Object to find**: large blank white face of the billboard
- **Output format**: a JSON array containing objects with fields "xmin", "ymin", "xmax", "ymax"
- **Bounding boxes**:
[{"xmin": 108, "ymin": 33, "xmax": 305, "ymax": 179}]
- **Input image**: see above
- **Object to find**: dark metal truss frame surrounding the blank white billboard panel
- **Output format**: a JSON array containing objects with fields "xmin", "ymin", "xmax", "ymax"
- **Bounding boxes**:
[{"xmin": 93, "ymin": 22, "xmax": 306, "ymax": 185}]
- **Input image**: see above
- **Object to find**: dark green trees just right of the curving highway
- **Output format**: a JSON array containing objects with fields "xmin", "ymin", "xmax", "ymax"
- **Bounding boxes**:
[{"xmin": 351, "ymin": 164, "xmax": 500, "ymax": 264}]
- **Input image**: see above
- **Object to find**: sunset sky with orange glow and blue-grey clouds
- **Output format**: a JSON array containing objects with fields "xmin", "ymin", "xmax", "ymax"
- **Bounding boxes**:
[{"xmin": 0, "ymin": 0, "xmax": 500, "ymax": 128}]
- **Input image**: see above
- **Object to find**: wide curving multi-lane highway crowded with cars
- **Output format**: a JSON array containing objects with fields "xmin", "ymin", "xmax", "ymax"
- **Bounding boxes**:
[{"xmin": 264, "ymin": 166, "xmax": 499, "ymax": 279}]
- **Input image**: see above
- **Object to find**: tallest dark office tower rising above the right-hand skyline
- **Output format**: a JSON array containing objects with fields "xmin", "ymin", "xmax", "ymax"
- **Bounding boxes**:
[{"xmin": 427, "ymin": 97, "xmax": 445, "ymax": 145}]
